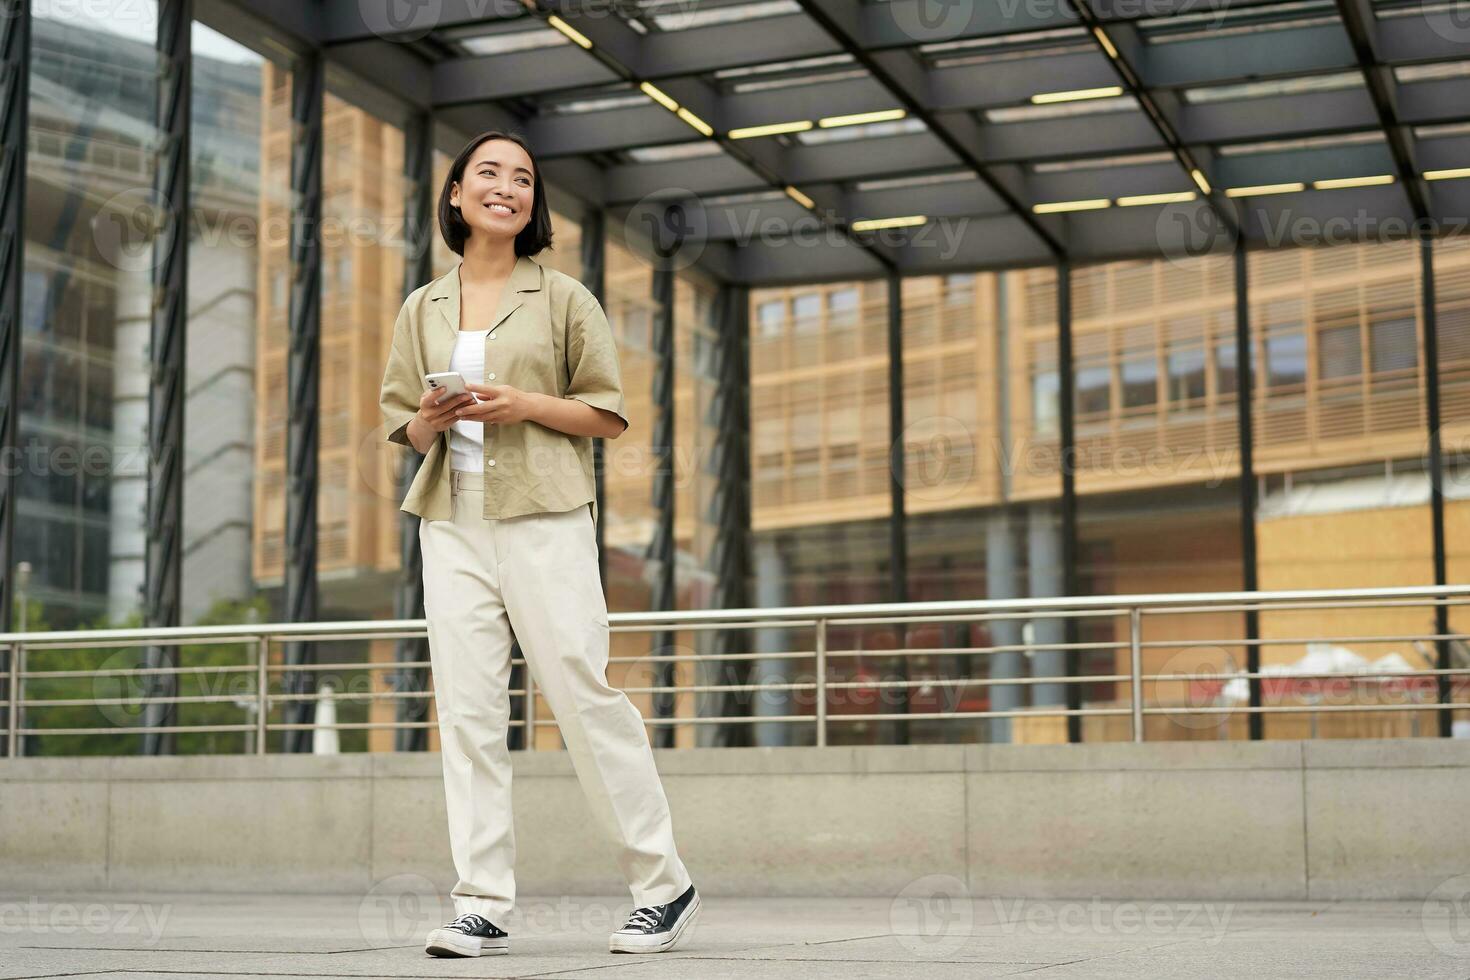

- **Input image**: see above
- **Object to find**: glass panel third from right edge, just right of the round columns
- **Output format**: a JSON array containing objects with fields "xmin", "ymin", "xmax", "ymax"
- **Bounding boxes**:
[{"xmin": 1057, "ymin": 256, "xmax": 1245, "ymax": 742}]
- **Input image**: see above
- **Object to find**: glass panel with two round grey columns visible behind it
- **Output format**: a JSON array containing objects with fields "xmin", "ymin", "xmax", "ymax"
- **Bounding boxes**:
[{"xmin": 894, "ymin": 269, "xmax": 1064, "ymax": 742}]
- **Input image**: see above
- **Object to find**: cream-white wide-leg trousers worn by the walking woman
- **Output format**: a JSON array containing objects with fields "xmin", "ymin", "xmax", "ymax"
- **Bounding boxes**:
[{"xmin": 419, "ymin": 472, "xmax": 689, "ymax": 923}]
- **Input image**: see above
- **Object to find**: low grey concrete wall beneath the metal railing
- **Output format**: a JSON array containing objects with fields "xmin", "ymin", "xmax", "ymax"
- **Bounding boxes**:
[{"xmin": 0, "ymin": 739, "xmax": 1470, "ymax": 899}]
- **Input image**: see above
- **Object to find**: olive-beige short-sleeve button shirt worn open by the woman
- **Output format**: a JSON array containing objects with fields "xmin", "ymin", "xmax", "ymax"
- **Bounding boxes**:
[{"xmin": 378, "ymin": 256, "xmax": 628, "ymax": 522}]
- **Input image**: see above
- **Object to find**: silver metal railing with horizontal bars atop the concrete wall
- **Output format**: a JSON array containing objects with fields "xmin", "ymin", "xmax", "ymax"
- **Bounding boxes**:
[{"xmin": 0, "ymin": 585, "xmax": 1470, "ymax": 757}]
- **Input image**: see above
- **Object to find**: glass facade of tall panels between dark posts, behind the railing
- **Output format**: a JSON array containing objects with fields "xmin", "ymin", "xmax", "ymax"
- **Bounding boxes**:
[{"xmin": 5, "ymin": 3, "xmax": 1470, "ymax": 748}]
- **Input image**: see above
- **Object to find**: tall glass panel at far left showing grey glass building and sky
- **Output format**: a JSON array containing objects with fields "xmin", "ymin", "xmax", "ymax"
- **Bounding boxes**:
[{"xmin": 15, "ymin": 0, "xmax": 160, "ymax": 631}]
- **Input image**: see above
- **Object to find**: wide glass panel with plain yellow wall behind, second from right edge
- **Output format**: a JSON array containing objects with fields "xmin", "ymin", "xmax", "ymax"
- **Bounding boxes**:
[{"xmin": 1252, "ymin": 242, "xmax": 1438, "ymax": 739}]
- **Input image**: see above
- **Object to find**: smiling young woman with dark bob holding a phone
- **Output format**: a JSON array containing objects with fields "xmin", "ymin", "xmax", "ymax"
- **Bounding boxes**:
[{"xmin": 379, "ymin": 131, "xmax": 700, "ymax": 956}]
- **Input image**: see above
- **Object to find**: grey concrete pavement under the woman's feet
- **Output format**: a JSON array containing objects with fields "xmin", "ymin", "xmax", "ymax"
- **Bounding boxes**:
[{"xmin": 0, "ymin": 893, "xmax": 1470, "ymax": 980}]
